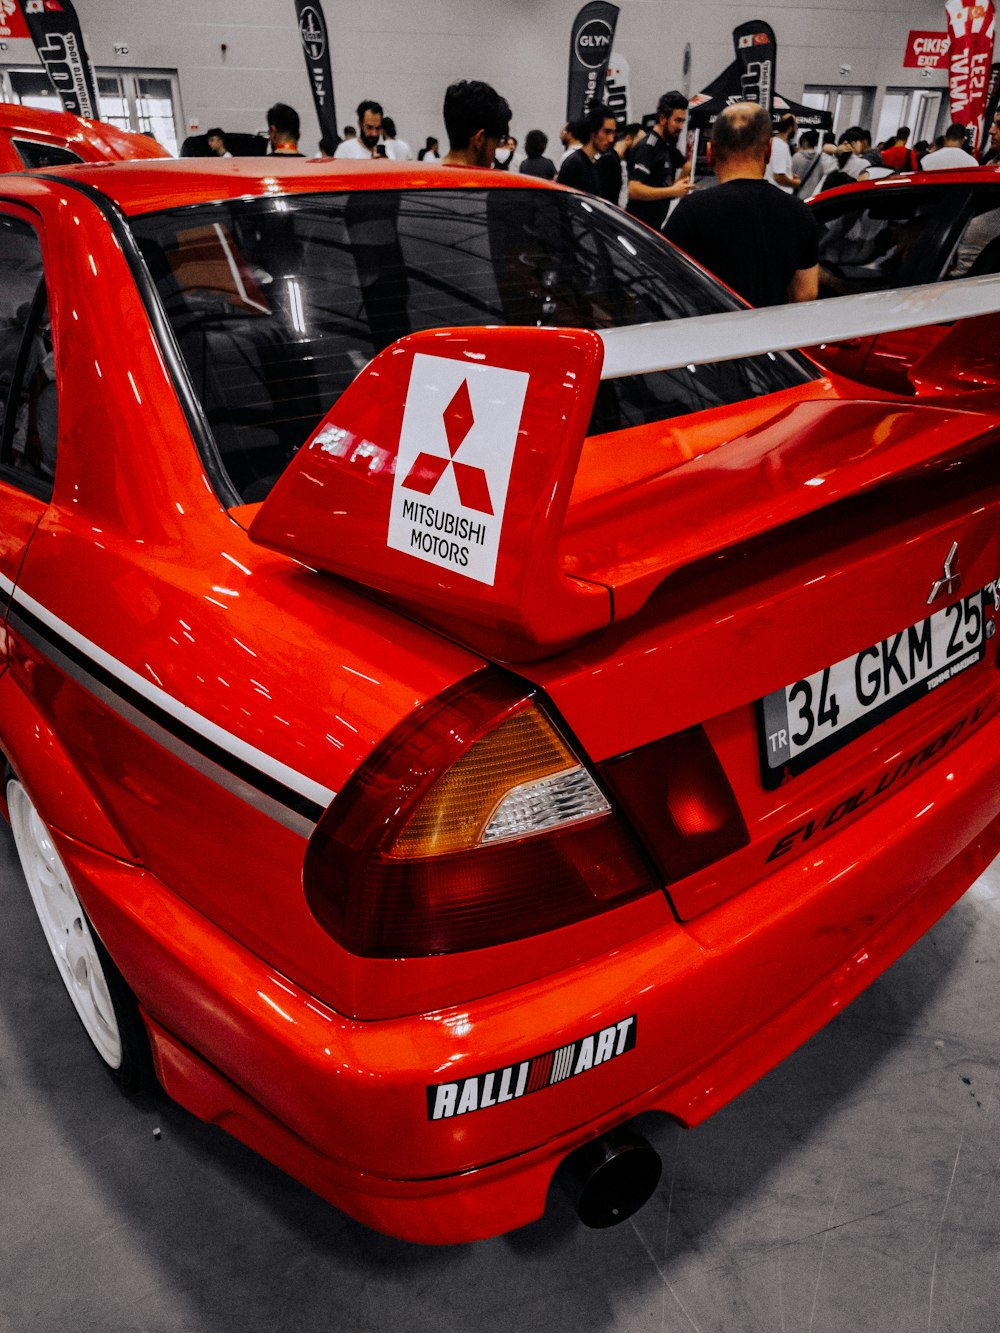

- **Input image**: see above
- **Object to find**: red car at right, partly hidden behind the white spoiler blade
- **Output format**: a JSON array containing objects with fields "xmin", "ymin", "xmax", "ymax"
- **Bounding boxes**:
[{"xmin": 809, "ymin": 165, "xmax": 1000, "ymax": 399}]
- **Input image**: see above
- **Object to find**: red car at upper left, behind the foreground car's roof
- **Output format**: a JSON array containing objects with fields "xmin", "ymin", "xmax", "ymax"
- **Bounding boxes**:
[{"xmin": 0, "ymin": 103, "xmax": 171, "ymax": 171}]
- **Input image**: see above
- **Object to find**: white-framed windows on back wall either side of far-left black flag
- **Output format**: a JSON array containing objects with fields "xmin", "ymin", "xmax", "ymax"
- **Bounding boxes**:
[{"xmin": 0, "ymin": 68, "xmax": 183, "ymax": 156}]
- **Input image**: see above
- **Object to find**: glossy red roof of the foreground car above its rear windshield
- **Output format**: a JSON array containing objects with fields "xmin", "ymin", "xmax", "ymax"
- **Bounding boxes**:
[{"xmin": 19, "ymin": 156, "xmax": 555, "ymax": 217}]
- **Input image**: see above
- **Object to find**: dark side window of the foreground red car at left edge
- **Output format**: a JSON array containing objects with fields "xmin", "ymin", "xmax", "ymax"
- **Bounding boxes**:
[{"xmin": 0, "ymin": 216, "xmax": 59, "ymax": 499}]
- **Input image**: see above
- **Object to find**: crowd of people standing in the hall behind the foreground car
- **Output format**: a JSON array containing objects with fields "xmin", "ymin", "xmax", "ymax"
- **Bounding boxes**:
[{"xmin": 193, "ymin": 80, "xmax": 1000, "ymax": 305}]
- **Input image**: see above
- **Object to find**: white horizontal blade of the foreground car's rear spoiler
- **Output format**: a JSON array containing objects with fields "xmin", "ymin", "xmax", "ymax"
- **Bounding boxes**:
[{"xmin": 599, "ymin": 273, "xmax": 1000, "ymax": 380}]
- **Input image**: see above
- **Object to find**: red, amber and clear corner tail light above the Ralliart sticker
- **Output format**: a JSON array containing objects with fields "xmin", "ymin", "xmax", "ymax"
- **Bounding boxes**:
[{"xmin": 304, "ymin": 670, "xmax": 659, "ymax": 957}]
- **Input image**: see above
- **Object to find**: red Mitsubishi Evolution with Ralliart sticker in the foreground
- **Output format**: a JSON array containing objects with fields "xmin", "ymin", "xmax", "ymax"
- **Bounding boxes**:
[{"xmin": 0, "ymin": 160, "xmax": 1000, "ymax": 1242}]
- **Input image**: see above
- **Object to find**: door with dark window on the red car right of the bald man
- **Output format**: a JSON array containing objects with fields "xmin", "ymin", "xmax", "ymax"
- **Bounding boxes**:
[{"xmin": 808, "ymin": 183, "xmax": 969, "ymax": 395}]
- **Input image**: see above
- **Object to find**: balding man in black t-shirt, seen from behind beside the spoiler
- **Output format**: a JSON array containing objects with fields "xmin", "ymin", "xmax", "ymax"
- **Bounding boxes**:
[{"xmin": 663, "ymin": 101, "xmax": 820, "ymax": 305}]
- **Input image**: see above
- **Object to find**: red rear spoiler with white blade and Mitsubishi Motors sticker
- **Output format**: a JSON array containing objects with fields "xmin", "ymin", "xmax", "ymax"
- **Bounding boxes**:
[{"xmin": 249, "ymin": 276, "xmax": 1000, "ymax": 661}]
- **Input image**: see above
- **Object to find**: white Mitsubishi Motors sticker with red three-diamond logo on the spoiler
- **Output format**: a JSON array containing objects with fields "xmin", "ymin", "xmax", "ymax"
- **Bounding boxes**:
[{"xmin": 388, "ymin": 352, "xmax": 528, "ymax": 585}]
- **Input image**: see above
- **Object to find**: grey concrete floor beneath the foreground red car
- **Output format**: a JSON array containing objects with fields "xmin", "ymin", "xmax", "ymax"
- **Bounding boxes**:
[{"xmin": 0, "ymin": 829, "xmax": 1000, "ymax": 1333}]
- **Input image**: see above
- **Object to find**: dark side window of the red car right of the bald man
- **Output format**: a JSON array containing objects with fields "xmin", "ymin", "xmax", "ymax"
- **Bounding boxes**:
[{"xmin": 815, "ymin": 189, "xmax": 952, "ymax": 296}]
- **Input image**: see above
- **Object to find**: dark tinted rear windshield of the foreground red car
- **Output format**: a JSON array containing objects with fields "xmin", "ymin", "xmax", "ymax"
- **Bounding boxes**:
[{"xmin": 132, "ymin": 189, "xmax": 816, "ymax": 503}]
